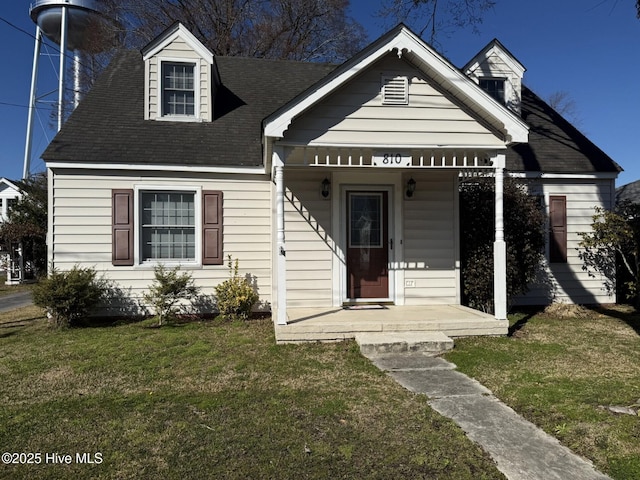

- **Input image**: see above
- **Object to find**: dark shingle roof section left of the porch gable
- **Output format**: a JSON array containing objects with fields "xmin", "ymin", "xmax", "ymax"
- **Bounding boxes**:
[{"xmin": 42, "ymin": 51, "xmax": 335, "ymax": 166}]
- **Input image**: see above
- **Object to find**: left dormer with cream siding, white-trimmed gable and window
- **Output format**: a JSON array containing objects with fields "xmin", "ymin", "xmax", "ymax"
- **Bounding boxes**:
[{"xmin": 142, "ymin": 23, "xmax": 220, "ymax": 122}]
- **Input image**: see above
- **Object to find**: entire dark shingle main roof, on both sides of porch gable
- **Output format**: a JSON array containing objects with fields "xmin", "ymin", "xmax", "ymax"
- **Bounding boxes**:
[{"xmin": 42, "ymin": 51, "xmax": 621, "ymax": 173}]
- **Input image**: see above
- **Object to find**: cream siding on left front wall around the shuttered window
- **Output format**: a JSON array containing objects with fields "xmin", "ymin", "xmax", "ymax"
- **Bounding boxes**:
[{"xmin": 51, "ymin": 172, "xmax": 272, "ymax": 309}]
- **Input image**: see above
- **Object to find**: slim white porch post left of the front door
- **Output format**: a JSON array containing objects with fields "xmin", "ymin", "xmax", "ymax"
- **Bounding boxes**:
[{"xmin": 273, "ymin": 147, "xmax": 287, "ymax": 325}]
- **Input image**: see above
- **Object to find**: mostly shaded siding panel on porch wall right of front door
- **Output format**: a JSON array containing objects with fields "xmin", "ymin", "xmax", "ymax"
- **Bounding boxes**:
[{"xmin": 403, "ymin": 172, "xmax": 459, "ymax": 305}]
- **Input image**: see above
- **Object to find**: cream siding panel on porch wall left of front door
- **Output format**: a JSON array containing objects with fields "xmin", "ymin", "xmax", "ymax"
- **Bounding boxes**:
[{"xmin": 285, "ymin": 171, "xmax": 335, "ymax": 307}]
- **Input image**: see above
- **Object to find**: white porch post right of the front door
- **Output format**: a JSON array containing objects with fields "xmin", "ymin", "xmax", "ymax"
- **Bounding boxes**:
[{"xmin": 493, "ymin": 153, "xmax": 507, "ymax": 320}]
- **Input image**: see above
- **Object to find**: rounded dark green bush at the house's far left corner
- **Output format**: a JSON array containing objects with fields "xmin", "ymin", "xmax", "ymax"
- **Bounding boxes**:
[{"xmin": 33, "ymin": 265, "xmax": 108, "ymax": 327}]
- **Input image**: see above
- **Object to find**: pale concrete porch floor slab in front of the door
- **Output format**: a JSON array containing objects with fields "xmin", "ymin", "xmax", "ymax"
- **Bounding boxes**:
[{"xmin": 275, "ymin": 305, "xmax": 509, "ymax": 343}]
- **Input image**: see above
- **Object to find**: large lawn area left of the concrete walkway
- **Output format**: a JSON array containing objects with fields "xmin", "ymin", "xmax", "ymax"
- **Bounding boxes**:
[{"xmin": 0, "ymin": 307, "xmax": 504, "ymax": 480}]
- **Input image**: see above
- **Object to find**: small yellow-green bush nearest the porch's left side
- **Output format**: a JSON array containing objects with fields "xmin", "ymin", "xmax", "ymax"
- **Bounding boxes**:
[{"xmin": 215, "ymin": 255, "xmax": 258, "ymax": 320}]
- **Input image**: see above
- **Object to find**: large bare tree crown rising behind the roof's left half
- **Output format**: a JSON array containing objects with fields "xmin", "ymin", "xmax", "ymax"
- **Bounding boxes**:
[{"xmin": 111, "ymin": 0, "xmax": 366, "ymax": 62}]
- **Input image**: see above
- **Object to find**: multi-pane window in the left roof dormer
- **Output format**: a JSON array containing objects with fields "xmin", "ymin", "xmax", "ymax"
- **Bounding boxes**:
[{"xmin": 162, "ymin": 62, "xmax": 196, "ymax": 117}]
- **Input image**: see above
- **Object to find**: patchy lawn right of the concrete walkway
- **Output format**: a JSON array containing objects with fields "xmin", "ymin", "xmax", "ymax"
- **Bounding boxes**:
[{"xmin": 446, "ymin": 307, "xmax": 640, "ymax": 480}]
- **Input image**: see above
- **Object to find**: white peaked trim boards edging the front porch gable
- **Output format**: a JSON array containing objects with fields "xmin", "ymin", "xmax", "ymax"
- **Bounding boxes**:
[{"xmin": 264, "ymin": 26, "xmax": 529, "ymax": 143}]
